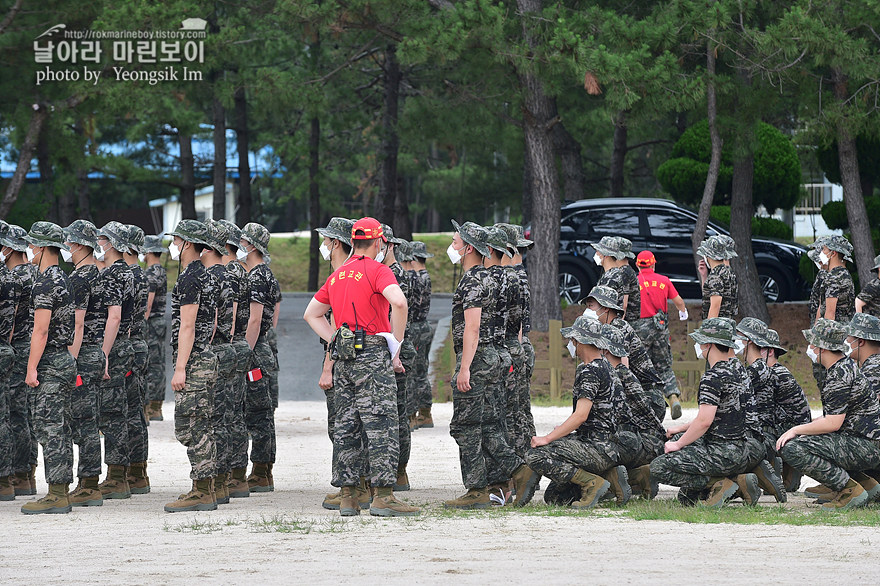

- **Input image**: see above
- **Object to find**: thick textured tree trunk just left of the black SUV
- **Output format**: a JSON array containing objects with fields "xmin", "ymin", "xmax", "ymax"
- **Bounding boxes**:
[{"xmin": 517, "ymin": 0, "xmax": 562, "ymax": 332}]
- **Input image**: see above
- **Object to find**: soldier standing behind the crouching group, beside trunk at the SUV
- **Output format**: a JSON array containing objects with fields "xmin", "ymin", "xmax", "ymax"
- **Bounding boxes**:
[{"xmin": 697, "ymin": 236, "xmax": 739, "ymax": 320}]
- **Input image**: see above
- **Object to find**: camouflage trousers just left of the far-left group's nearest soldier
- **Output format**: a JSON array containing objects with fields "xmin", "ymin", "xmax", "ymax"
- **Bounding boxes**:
[{"xmin": 9, "ymin": 339, "xmax": 37, "ymax": 473}]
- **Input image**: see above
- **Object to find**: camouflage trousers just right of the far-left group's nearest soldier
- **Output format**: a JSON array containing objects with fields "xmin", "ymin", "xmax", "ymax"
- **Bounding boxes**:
[{"xmin": 70, "ymin": 344, "xmax": 104, "ymax": 478}]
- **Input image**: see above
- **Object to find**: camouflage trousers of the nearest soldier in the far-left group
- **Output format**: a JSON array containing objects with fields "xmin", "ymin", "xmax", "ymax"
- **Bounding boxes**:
[{"xmin": 30, "ymin": 348, "xmax": 76, "ymax": 484}]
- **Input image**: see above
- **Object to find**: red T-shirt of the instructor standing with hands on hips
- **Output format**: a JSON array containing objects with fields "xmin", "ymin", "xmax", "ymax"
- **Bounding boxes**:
[{"xmin": 315, "ymin": 256, "xmax": 397, "ymax": 335}]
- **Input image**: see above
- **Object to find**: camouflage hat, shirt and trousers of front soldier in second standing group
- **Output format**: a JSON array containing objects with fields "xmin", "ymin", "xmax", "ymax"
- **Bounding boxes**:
[{"xmin": 171, "ymin": 238, "xmax": 218, "ymax": 480}]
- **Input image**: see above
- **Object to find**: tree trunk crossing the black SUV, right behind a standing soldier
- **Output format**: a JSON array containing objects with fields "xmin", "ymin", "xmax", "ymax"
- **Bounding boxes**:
[{"xmin": 730, "ymin": 153, "xmax": 770, "ymax": 323}]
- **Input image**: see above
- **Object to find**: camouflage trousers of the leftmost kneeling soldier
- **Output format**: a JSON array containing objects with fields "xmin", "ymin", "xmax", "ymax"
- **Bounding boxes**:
[{"xmin": 526, "ymin": 434, "xmax": 618, "ymax": 482}]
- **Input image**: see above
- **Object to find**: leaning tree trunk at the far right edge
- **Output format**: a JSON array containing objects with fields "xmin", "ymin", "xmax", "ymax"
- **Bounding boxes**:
[{"xmin": 834, "ymin": 70, "xmax": 875, "ymax": 283}]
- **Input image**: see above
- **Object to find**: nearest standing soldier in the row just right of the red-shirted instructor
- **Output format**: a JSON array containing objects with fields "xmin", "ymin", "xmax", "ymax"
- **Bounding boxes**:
[{"xmin": 444, "ymin": 222, "xmax": 540, "ymax": 509}]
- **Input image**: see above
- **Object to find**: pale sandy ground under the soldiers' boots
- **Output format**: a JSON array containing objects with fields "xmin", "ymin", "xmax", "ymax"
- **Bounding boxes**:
[{"xmin": 0, "ymin": 402, "xmax": 880, "ymax": 584}]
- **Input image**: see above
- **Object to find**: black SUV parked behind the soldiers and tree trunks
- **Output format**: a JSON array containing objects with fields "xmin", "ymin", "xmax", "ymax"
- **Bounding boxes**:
[{"xmin": 559, "ymin": 198, "xmax": 808, "ymax": 303}]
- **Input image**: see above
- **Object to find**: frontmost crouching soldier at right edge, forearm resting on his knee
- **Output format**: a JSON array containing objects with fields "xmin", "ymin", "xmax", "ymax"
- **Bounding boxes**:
[{"xmin": 776, "ymin": 318, "xmax": 880, "ymax": 509}]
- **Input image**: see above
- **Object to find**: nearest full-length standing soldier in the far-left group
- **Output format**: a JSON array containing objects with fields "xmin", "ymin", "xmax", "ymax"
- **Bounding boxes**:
[{"xmin": 21, "ymin": 222, "xmax": 76, "ymax": 515}]
